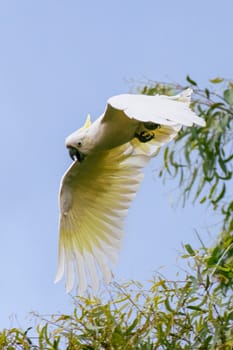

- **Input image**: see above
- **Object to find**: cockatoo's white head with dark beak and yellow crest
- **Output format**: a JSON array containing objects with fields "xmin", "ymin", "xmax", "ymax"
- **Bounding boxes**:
[{"xmin": 65, "ymin": 115, "xmax": 91, "ymax": 162}]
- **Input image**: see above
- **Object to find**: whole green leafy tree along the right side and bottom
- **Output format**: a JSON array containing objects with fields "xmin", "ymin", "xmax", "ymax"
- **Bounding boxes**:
[{"xmin": 0, "ymin": 77, "xmax": 233, "ymax": 350}]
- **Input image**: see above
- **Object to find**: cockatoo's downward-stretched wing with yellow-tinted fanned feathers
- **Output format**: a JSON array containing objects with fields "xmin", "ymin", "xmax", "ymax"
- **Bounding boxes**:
[{"xmin": 56, "ymin": 143, "xmax": 150, "ymax": 294}]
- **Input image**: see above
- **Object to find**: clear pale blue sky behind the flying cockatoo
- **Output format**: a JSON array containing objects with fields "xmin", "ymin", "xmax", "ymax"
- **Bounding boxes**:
[{"xmin": 0, "ymin": 0, "xmax": 233, "ymax": 328}]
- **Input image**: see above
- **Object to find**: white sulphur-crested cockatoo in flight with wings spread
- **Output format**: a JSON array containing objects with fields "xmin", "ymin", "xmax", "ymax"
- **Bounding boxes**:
[{"xmin": 55, "ymin": 89, "xmax": 205, "ymax": 294}]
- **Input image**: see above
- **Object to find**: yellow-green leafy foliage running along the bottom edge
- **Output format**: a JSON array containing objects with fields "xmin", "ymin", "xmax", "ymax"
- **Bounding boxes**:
[{"xmin": 0, "ymin": 244, "xmax": 233, "ymax": 350}]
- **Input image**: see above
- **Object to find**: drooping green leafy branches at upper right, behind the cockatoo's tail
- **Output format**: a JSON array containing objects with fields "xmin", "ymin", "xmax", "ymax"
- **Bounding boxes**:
[{"xmin": 142, "ymin": 77, "xmax": 233, "ymax": 212}]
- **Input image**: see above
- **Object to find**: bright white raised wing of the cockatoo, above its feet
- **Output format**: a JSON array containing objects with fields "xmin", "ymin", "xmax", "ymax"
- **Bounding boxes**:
[{"xmin": 104, "ymin": 89, "xmax": 205, "ymax": 126}]
